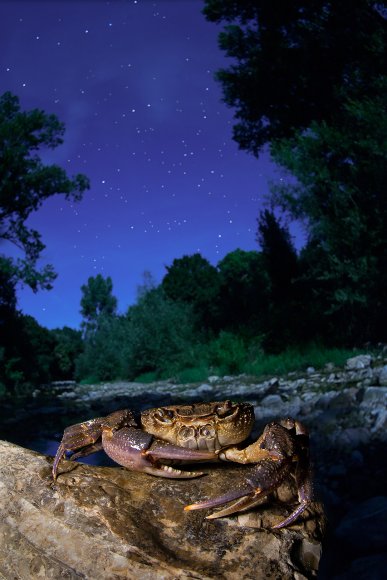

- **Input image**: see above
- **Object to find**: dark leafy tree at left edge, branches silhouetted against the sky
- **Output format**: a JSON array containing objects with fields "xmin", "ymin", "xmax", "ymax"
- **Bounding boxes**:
[{"xmin": 0, "ymin": 92, "xmax": 89, "ymax": 291}]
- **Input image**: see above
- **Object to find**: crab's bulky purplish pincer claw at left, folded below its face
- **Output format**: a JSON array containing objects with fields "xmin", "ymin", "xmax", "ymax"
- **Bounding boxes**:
[{"xmin": 102, "ymin": 427, "xmax": 214, "ymax": 479}]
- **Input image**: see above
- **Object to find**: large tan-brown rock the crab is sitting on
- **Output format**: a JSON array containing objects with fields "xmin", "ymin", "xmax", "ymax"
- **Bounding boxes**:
[{"xmin": 0, "ymin": 441, "xmax": 324, "ymax": 580}]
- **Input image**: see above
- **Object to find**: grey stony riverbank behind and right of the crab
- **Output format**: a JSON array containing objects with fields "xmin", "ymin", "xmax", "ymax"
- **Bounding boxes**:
[{"xmin": 0, "ymin": 355, "xmax": 387, "ymax": 580}]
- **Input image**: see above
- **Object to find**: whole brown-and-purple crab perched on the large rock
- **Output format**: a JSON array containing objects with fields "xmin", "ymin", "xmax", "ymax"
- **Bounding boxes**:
[{"xmin": 52, "ymin": 401, "xmax": 312, "ymax": 529}]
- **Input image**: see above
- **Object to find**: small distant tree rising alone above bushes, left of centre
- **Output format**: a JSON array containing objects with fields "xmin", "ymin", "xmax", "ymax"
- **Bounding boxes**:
[{"xmin": 81, "ymin": 274, "xmax": 117, "ymax": 335}]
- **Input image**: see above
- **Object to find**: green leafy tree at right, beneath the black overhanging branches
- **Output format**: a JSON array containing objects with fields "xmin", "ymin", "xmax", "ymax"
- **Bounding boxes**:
[{"xmin": 274, "ymin": 92, "xmax": 387, "ymax": 342}]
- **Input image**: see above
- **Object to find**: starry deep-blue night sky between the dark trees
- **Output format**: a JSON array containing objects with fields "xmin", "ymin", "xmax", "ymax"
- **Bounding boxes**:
[{"xmin": 0, "ymin": 0, "xmax": 288, "ymax": 328}]
